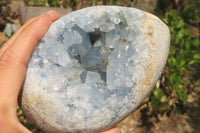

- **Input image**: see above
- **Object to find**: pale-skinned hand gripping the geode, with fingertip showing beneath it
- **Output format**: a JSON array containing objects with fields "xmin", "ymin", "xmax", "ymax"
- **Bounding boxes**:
[{"xmin": 0, "ymin": 11, "xmax": 120, "ymax": 133}]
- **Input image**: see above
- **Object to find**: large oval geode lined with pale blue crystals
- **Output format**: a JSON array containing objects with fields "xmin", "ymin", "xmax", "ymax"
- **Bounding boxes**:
[{"xmin": 22, "ymin": 6, "xmax": 170, "ymax": 133}]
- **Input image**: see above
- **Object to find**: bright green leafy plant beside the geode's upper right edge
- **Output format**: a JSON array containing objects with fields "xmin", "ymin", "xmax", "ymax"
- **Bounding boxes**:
[{"xmin": 164, "ymin": 10, "xmax": 200, "ymax": 71}]
